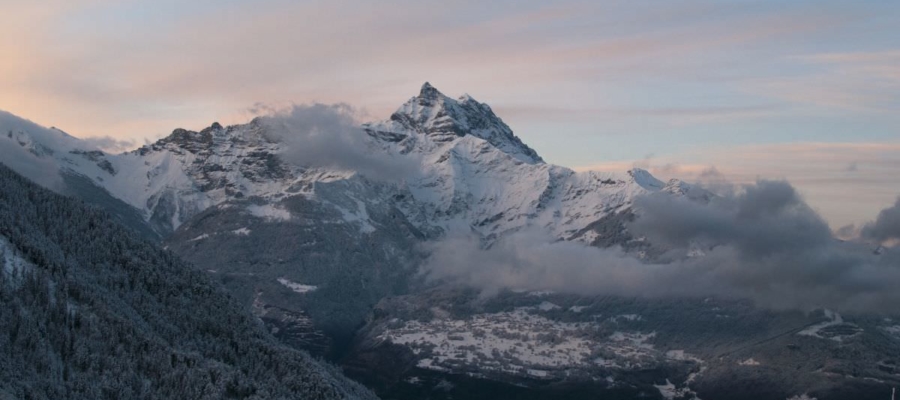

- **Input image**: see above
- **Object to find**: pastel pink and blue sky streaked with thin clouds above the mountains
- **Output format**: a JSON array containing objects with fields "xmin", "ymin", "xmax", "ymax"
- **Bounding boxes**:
[{"xmin": 0, "ymin": 0, "xmax": 900, "ymax": 228}]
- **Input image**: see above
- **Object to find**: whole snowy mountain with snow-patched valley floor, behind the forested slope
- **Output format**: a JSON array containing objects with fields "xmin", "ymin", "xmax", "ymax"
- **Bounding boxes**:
[{"xmin": 0, "ymin": 83, "xmax": 900, "ymax": 399}]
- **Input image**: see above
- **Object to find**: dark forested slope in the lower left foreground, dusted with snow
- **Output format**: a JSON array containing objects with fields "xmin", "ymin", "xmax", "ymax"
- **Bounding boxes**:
[{"xmin": 0, "ymin": 165, "xmax": 374, "ymax": 399}]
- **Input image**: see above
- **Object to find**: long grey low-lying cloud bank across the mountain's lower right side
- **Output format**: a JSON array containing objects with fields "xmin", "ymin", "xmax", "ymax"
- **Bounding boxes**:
[{"xmin": 425, "ymin": 181, "xmax": 900, "ymax": 312}]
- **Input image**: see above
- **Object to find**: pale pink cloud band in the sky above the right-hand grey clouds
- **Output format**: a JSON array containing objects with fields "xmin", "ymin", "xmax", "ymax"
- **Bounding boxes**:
[{"xmin": 575, "ymin": 141, "xmax": 900, "ymax": 227}]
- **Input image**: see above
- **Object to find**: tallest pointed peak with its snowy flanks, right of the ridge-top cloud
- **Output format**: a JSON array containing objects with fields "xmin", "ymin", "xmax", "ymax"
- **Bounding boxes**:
[{"xmin": 365, "ymin": 83, "xmax": 688, "ymax": 241}]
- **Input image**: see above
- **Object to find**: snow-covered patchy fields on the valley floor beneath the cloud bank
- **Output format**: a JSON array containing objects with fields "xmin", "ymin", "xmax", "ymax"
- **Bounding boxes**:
[{"xmin": 379, "ymin": 302, "xmax": 663, "ymax": 378}]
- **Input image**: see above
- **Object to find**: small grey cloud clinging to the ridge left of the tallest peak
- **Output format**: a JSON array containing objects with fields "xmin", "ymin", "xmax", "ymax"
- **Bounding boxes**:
[{"xmin": 254, "ymin": 104, "xmax": 422, "ymax": 181}]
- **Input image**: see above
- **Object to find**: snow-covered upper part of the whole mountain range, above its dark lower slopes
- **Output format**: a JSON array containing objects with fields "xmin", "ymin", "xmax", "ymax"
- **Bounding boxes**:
[{"xmin": 0, "ymin": 83, "xmax": 688, "ymax": 242}]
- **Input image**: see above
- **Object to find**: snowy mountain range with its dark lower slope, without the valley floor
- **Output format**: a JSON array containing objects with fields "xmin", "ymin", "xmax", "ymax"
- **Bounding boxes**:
[{"xmin": 0, "ymin": 83, "xmax": 704, "ymax": 358}]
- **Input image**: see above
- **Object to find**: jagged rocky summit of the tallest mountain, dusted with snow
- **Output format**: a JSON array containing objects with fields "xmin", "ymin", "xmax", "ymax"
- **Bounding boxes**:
[{"xmin": 391, "ymin": 82, "xmax": 544, "ymax": 164}]
